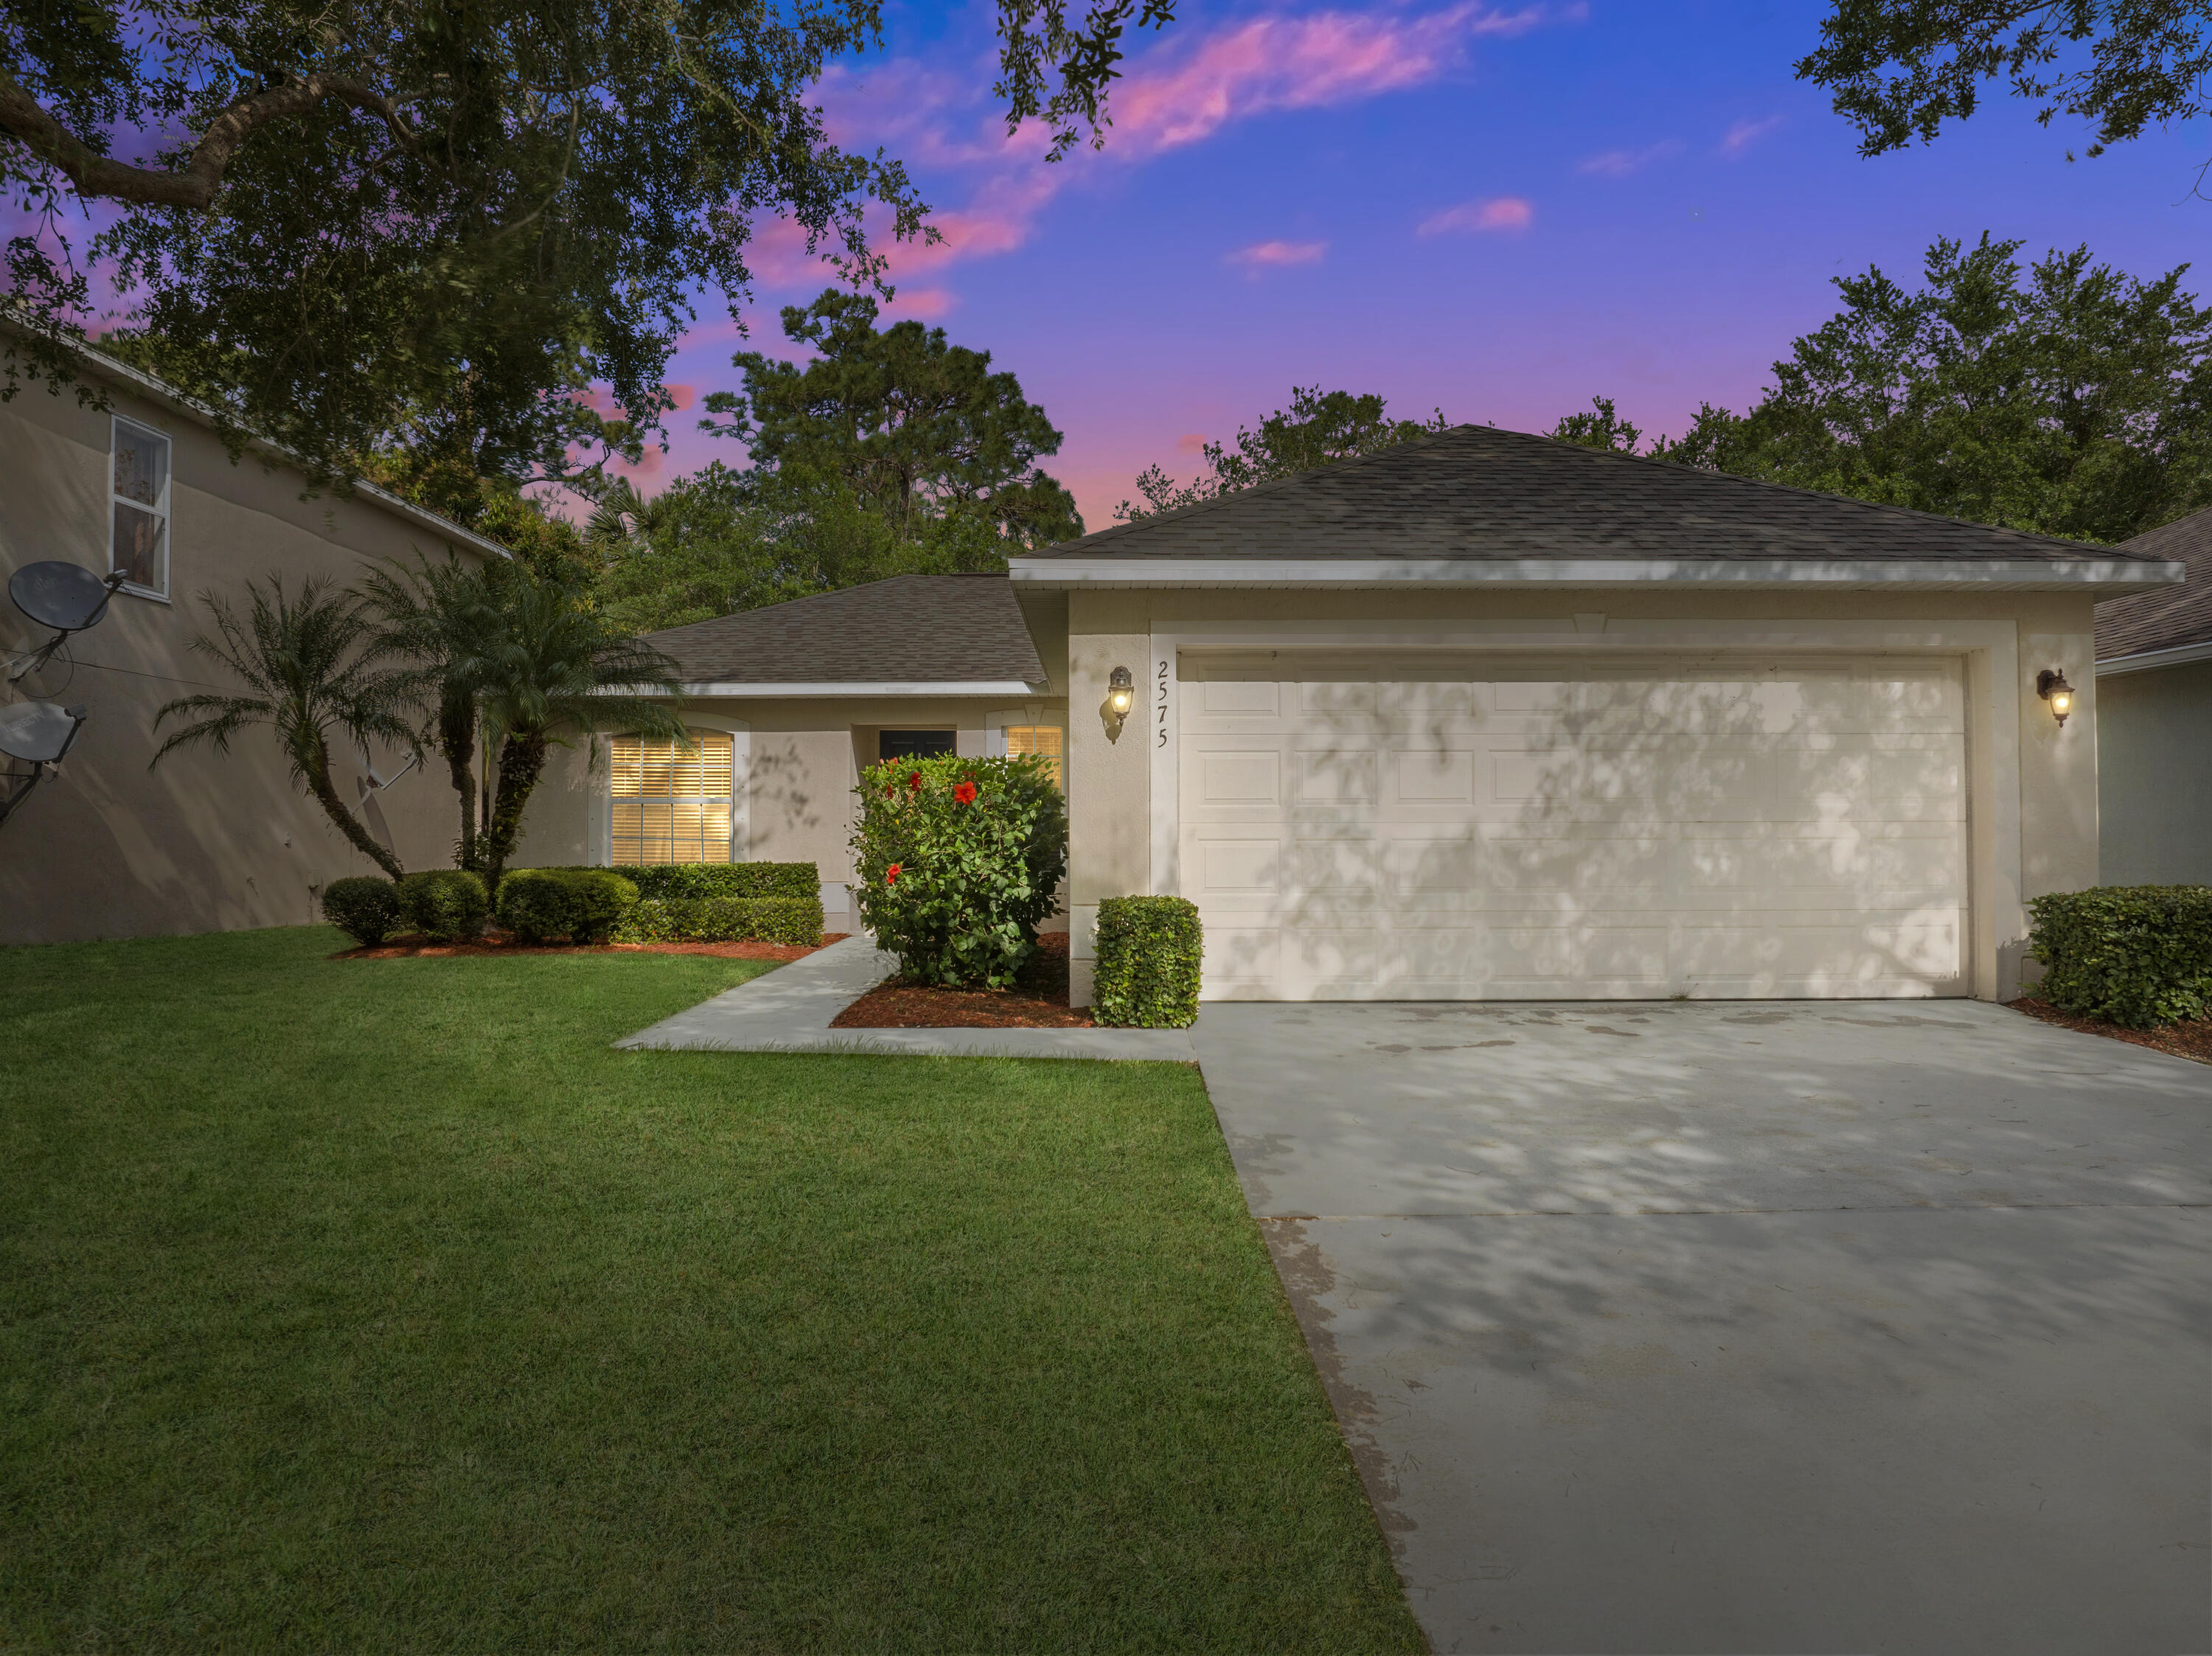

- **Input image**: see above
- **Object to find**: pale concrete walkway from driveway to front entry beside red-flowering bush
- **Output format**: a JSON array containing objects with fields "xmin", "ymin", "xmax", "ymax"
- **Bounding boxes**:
[{"xmin": 615, "ymin": 935, "xmax": 1197, "ymax": 1063}]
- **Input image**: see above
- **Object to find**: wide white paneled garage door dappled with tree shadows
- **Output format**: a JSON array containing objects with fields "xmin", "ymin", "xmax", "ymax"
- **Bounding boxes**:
[{"xmin": 1177, "ymin": 653, "xmax": 1966, "ymax": 999}]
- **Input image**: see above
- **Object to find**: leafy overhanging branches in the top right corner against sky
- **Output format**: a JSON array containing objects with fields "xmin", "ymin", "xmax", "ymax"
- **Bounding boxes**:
[{"xmin": 1796, "ymin": 0, "xmax": 2212, "ymax": 155}]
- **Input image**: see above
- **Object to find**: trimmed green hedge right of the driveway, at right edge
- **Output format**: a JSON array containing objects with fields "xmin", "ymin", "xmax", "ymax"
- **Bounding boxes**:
[{"xmin": 2028, "ymin": 886, "xmax": 2212, "ymax": 1028}]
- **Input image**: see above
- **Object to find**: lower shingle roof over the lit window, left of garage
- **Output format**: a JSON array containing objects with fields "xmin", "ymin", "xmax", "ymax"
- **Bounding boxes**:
[{"xmin": 646, "ymin": 575, "xmax": 1044, "ymax": 686}]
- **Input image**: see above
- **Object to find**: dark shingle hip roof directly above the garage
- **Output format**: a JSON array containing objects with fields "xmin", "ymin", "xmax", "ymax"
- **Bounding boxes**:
[{"xmin": 1022, "ymin": 425, "xmax": 2148, "ymax": 566}]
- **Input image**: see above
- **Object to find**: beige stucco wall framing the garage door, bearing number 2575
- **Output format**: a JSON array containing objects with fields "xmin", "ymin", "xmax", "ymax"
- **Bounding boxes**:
[{"xmin": 1066, "ymin": 586, "xmax": 2099, "ymax": 999}]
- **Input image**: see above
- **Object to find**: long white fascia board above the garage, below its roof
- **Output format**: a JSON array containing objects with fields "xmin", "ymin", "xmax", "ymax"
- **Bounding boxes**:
[{"xmin": 1006, "ymin": 557, "xmax": 2188, "ymax": 588}]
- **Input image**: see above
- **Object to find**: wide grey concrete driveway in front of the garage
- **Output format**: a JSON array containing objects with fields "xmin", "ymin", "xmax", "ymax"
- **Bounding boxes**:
[{"xmin": 1194, "ymin": 1001, "xmax": 2212, "ymax": 1656}]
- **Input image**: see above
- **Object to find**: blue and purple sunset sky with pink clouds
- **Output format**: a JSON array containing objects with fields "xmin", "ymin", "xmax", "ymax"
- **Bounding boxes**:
[{"xmin": 639, "ymin": 0, "xmax": 2212, "ymax": 529}]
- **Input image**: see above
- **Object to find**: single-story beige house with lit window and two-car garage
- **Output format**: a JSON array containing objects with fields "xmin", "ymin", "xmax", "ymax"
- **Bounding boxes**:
[{"xmin": 531, "ymin": 427, "xmax": 2183, "ymax": 999}]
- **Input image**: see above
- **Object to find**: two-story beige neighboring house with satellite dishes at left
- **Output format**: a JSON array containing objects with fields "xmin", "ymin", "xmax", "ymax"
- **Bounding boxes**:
[{"xmin": 0, "ymin": 338, "xmax": 504, "ymax": 944}]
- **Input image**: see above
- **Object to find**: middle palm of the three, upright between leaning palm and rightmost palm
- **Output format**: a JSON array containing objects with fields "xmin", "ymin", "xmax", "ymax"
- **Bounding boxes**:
[{"xmin": 361, "ymin": 553, "xmax": 507, "ymax": 869}]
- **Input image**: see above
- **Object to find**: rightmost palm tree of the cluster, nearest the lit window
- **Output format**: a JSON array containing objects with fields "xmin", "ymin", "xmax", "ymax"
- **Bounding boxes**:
[{"xmin": 467, "ymin": 568, "xmax": 690, "ymax": 891}]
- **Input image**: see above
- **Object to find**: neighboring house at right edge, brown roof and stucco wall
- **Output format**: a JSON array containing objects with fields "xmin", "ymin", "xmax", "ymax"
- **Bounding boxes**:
[{"xmin": 2097, "ymin": 511, "xmax": 2212, "ymax": 884}]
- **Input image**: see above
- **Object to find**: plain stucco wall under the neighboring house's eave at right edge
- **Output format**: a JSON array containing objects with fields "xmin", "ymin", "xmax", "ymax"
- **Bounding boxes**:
[{"xmin": 2097, "ymin": 661, "xmax": 2212, "ymax": 884}]
